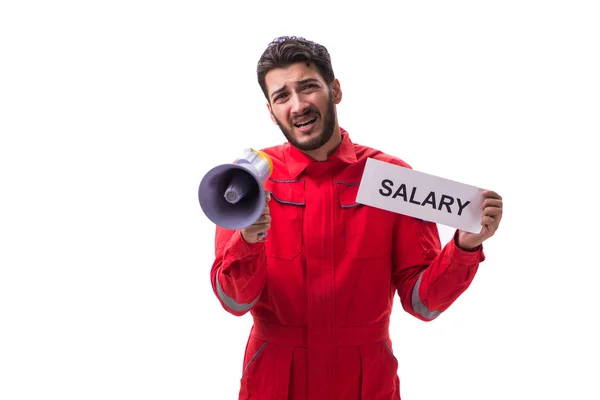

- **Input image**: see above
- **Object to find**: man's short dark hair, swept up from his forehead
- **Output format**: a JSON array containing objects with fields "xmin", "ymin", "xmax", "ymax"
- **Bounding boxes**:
[{"xmin": 256, "ymin": 36, "xmax": 335, "ymax": 100}]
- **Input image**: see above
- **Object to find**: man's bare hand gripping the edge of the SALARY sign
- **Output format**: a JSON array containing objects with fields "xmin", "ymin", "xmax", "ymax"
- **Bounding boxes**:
[{"xmin": 458, "ymin": 190, "xmax": 502, "ymax": 250}]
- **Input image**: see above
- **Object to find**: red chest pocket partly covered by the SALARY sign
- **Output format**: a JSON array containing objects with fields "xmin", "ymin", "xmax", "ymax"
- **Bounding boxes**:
[{"xmin": 336, "ymin": 182, "xmax": 394, "ymax": 259}]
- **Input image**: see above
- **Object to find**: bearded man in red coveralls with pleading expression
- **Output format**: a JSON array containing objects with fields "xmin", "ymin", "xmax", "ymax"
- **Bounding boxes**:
[{"xmin": 210, "ymin": 37, "xmax": 502, "ymax": 400}]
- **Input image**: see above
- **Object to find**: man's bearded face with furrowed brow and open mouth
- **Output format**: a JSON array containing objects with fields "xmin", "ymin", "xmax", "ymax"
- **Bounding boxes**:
[{"xmin": 265, "ymin": 63, "xmax": 341, "ymax": 151}]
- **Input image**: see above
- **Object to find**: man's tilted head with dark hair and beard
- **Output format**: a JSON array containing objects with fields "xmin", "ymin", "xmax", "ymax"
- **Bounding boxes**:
[{"xmin": 257, "ymin": 36, "xmax": 342, "ymax": 152}]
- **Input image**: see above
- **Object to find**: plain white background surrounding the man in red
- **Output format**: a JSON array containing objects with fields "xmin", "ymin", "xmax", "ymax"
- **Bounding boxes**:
[{"xmin": 0, "ymin": 0, "xmax": 600, "ymax": 400}]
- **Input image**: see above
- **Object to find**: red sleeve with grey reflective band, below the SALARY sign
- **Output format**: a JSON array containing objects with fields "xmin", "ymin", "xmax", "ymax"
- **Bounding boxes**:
[{"xmin": 392, "ymin": 215, "xmax": 485, "ymax": 321}]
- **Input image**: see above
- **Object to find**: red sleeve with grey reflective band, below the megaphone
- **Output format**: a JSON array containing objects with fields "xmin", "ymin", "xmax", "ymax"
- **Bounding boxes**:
[{"xmin": 210, "ymin": 227, "xmax": 267, "ymax": 316}]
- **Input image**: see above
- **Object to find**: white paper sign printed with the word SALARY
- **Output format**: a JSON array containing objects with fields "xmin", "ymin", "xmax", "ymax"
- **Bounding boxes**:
[{"xmin": 356, "ymin": 158, "xmax": 483, "ymax": 233}]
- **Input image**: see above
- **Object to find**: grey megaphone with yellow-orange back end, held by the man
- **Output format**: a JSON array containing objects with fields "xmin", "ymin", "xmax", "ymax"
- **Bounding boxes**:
[{"xmin": 198, "ymin": 149, "xmax": 273, "ymax": 230}]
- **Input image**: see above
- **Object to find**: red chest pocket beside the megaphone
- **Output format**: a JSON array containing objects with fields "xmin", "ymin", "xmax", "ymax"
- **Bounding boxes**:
[{"xmin": 265, "ymin": 180, "xmax": 306, "ymax": 260}]
